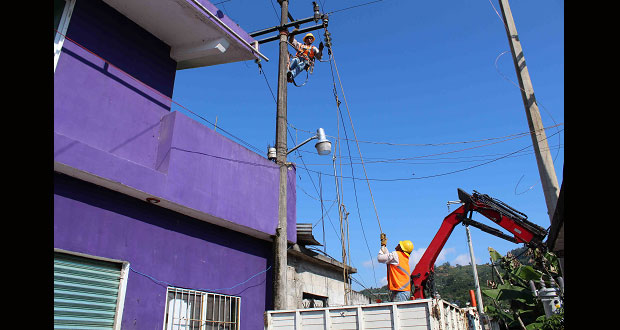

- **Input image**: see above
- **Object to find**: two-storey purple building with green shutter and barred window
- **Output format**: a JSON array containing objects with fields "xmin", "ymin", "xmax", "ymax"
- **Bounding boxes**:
[{"xmin": 54, "ymin": 0, "xmax": 296, "ymax": 330}]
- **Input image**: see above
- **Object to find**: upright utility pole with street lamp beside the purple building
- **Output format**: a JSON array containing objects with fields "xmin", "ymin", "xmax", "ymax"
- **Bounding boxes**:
[{"xmin": 273, "ymin": 0, "xmax": 288, "ymax": 310}]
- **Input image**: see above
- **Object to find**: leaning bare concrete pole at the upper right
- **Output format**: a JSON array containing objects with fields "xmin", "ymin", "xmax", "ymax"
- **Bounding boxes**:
[{"xmin": 499, "ymin": 0, "xmax": 560, "ymax": 221}]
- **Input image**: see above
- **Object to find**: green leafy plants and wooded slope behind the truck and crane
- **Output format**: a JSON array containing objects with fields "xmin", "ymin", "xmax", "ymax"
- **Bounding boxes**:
[{"xmin": 361, "ymin": 246, "xmax": 564, "ymax": 330}]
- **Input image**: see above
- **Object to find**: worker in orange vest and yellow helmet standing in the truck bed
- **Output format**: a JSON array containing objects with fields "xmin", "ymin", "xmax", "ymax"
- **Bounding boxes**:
[{"xmin": 377, "ymin": 233, "xmax": 413, "ymax": 301}]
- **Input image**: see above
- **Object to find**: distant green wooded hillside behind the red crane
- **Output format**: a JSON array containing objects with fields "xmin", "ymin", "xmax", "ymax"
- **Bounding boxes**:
[{"xmin": 360, "ymin": 247, "xmax": 528, "ymax": 307}]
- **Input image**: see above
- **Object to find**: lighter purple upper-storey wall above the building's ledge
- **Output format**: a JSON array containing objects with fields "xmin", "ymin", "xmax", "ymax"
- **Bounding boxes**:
[{"xmin": 54, "ymin": 0, "xmax": 296, "ymax": 242}]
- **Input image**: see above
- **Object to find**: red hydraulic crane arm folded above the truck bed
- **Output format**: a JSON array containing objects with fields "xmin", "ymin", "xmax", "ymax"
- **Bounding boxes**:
[{"xmin": 411, "ymin": 188, "xmax": 547, "ymax": 299}]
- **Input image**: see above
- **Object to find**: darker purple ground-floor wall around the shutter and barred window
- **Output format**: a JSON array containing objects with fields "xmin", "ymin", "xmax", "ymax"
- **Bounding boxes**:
[{"xmin": 54, "ymin": 174, "xmax": 273, "ymax": 330}]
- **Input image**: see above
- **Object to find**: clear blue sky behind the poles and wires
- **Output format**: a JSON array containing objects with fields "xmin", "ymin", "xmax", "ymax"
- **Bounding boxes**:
[{"xmin": 168, "ymin": 0, "xmax": 564, "ymax": 290}]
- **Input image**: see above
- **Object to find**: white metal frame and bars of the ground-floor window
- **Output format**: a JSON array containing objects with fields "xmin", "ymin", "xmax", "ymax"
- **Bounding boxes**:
[{"xmin": 162, "ymin": 286, "xmax": 241, "ymax": 330}]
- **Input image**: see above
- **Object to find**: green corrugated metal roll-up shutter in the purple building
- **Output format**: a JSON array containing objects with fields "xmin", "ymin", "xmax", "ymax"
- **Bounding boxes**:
[{"xmin": 54, "ymin": 252, "xmax": 121, "ymax": 329}]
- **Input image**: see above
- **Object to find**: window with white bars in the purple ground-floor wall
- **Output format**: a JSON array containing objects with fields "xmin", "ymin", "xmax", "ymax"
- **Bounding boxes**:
[{"xmin": 164, "ymin": 287, "xmax": 241, "ymax": 330}]
